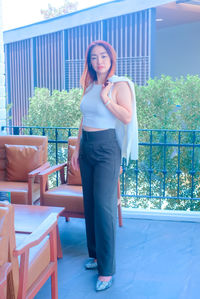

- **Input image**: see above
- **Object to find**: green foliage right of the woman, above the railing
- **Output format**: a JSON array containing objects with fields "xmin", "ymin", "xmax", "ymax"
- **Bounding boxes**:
[{"xmin": 136, "ymin": 75, "xmax": 200, "ymax": 130}]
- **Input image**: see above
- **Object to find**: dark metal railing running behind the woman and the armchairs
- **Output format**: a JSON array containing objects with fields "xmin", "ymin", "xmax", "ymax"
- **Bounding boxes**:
[{"xmin": 2, "ymin": 126, "xmax": 200, "ymax": 210}]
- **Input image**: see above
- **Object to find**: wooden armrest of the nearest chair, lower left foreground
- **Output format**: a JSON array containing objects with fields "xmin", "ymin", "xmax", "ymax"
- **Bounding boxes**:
[{"xmin": 13, "ymin": 213, "xmax": 57, "ymax": 256}]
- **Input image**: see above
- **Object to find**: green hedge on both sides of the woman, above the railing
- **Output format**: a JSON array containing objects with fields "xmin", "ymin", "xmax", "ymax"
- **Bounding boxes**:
[{"xmin": 23, "ymin": 75, "xmax": 200, "ymax": 130}]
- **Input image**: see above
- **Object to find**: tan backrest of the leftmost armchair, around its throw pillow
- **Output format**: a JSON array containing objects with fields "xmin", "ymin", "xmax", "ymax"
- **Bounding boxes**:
[{"xmin": 0, "ymin": 135, "xmax": 48, "ymax": 181}]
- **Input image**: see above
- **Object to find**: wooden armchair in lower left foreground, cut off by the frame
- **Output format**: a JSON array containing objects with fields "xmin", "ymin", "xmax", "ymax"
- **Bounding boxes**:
[{"xmin": 0, "ymin": 201, "xmax": 58, "ymax": 299}]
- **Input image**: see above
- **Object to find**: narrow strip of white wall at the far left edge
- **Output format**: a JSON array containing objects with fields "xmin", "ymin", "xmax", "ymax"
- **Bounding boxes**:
[{"xmin": 0, "ymin": 0, "xmax": 6, "ymax": 127}]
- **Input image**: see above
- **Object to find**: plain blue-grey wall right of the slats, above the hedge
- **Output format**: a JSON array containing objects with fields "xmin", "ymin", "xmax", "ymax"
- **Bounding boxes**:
[{"xmin": 154, "ymin": 22, "xmax": 200, "ymax": 78}]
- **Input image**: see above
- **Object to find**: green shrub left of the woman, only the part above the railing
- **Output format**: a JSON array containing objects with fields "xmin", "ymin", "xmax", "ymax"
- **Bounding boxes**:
[{"xmin": 23, "ymin": 88, "xmax": 82, "ymax": 127}]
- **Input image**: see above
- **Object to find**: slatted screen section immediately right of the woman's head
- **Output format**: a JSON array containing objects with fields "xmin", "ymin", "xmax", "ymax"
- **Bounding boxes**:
[{"xmin": 104, "ymin": 10, "xmax": 151, "ymax": 85}]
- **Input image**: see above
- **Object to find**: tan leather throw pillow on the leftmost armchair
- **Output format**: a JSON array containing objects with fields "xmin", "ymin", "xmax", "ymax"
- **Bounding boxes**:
[{"xmin": 5, "ymin": 144, "xmax": 42, "ymax": 182}]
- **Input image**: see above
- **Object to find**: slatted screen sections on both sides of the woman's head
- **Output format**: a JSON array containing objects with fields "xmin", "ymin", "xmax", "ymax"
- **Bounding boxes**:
[{"xmin": 65, "ymin": 10, "xmax": 151, "ymax": 90}]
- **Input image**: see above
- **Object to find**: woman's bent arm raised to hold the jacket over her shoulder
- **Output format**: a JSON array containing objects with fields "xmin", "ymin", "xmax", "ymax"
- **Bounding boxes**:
[{"xmin": 101, "ymin": 81, "xmax": 133, "ymax": 124}]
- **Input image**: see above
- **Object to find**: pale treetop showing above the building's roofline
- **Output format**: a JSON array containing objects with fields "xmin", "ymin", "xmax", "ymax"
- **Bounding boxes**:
[{"xmin": 40, "ymin": 0, "xmax": 78, "ymax": 20}]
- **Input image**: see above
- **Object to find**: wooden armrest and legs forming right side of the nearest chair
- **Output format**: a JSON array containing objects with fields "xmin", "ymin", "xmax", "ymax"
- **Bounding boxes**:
[{"xmin": 13, "ymin": 213, "xmax": 58, "ymax": 299}]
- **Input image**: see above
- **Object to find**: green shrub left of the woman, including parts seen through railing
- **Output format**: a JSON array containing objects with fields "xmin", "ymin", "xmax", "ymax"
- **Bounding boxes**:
[{"xmin": 23, "ymin": 88, "xmax": 82, "ymax": 184}]
